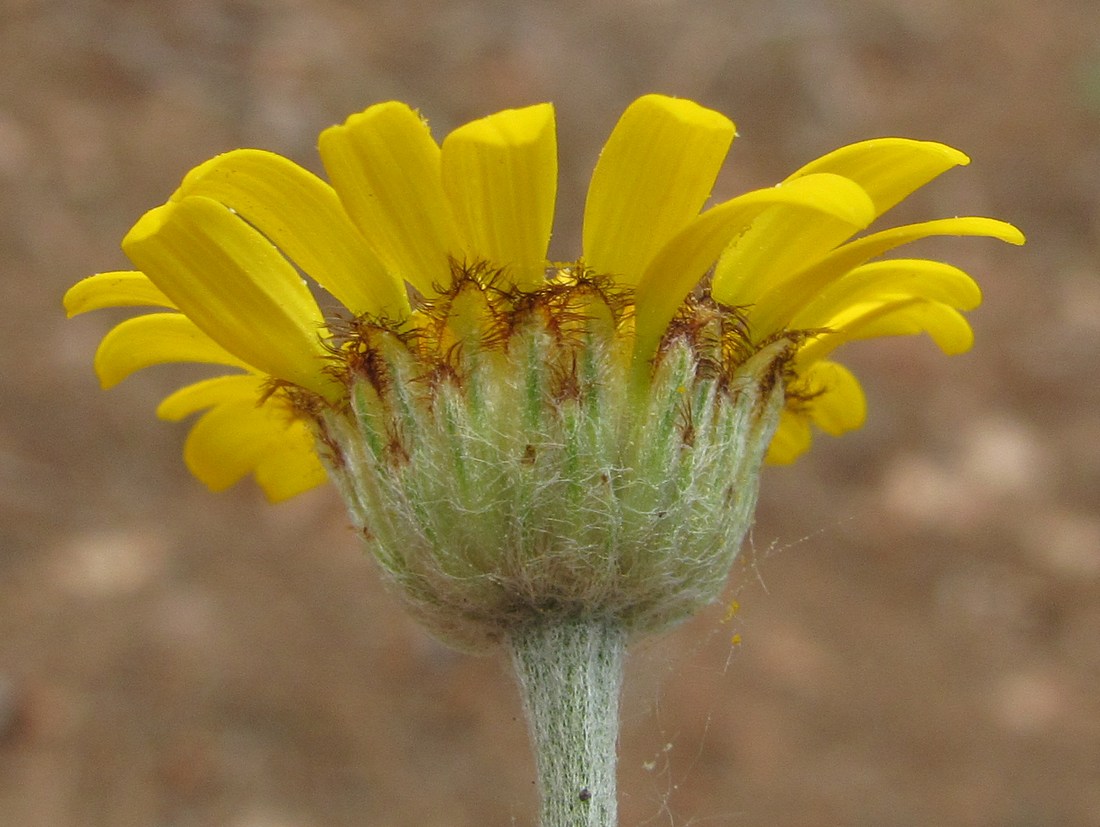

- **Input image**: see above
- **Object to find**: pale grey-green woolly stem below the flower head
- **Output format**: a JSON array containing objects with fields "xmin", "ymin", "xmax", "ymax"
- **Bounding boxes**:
[{"xmin": 508, "ymin": 618, "xmax": 626, "ymax": 827}]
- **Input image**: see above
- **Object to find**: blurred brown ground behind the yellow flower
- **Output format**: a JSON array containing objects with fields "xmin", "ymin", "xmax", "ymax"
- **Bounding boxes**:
[{"xmin": 0, "ymin": 0, "xmax": 1100, "ymax": 827}]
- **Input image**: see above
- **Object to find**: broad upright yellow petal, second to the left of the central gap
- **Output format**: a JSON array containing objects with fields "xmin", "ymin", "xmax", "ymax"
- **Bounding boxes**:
[{"xmin": 318, "ymin": 101, "xmax": 464, "ymax": 297}]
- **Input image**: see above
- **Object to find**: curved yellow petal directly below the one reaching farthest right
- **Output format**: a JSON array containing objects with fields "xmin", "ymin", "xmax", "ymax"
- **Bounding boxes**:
[{"xmin": 791, "ymin": 258, "xmax": 981, "ymax": 329}]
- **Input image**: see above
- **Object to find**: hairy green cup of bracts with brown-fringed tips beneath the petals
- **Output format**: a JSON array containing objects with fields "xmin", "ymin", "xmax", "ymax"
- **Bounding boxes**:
[{"xmin": 319, "ymin": 288, "xmax": 790, "ymax": 649}]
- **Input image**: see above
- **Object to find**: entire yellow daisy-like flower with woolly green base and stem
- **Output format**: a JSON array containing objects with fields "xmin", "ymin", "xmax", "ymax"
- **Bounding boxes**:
[{"xmin": 65, "ymin": 96, "xmax": 1023, "ymax": 824}]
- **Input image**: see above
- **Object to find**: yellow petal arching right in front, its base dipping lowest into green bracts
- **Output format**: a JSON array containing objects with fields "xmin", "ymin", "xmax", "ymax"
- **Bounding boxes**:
[{"xmin": 635, "ymin": 174, "xmax": 873, "ymax": 370}]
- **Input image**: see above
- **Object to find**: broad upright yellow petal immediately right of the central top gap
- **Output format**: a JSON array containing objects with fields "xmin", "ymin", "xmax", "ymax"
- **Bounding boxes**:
[{"xmin": 583, "ymin": 95, "xmax": 735, "ymax": 285}]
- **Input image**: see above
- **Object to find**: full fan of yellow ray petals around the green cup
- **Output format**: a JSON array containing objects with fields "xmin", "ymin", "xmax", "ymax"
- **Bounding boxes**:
[{"xmin": 65, "ymin": 95, "xmax": 1023, "ymax": 500}]
